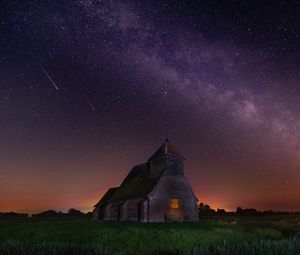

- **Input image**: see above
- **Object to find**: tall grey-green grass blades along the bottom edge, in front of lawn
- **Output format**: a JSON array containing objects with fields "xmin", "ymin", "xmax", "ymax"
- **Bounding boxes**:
[{"xmin": 0, "ymin": 238, "xmax": 300, "ymax": 255}]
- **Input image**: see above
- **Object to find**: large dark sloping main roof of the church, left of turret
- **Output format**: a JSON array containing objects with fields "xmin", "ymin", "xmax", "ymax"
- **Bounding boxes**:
[{"xmin": 111, "ymin": 163, "xmax": 162, "ymax": 202}]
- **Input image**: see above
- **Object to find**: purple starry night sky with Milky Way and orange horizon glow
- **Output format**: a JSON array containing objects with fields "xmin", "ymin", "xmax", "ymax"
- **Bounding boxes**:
[{"xmin": 0, "ymin": 0, "xmax": 300, "ymax": 213}]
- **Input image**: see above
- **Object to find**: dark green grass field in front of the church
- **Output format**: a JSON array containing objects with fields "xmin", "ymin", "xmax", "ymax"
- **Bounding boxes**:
[{"xmin": 0, "ymin": 218, "xmax": 300, "ymax": 255}]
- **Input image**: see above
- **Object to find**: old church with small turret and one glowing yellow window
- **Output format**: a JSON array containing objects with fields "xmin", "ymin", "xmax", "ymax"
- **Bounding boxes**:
[{"xmin": 93, "ymin": 139, "xmax": 199, "ymax": 222}]
